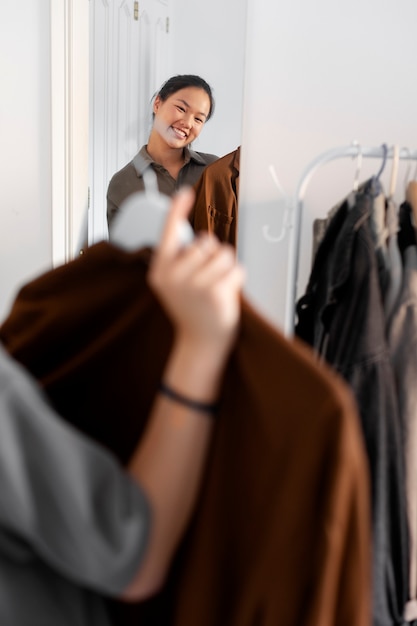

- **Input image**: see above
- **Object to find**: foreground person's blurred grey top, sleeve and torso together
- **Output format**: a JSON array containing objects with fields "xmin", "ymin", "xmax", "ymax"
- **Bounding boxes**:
[{"xmin": 0, "ymin": 347, "xmax": 149, "ymax": 626}]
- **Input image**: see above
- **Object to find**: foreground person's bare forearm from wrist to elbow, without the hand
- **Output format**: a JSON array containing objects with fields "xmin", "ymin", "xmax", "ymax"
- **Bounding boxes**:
[{"xmin": 120, "ymin": 341, "xmax": 225, "ymax": 599}]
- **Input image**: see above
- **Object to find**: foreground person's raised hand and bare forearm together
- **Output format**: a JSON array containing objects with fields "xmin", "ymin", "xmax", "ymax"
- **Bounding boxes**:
[{"xmin": 120, "ymin": 190, "xmax": 244, "ymax": 599}]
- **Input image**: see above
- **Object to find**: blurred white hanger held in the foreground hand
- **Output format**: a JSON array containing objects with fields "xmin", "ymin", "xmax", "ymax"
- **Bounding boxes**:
[{"xmin": 109, "ymin": 167, "xmax": 194, "ymax": 251}]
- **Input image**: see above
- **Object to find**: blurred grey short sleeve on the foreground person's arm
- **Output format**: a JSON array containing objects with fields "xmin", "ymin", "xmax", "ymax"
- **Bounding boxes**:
[{"xmin": 0, "ymin": 348, "xmax": 150, "ymax": 594}]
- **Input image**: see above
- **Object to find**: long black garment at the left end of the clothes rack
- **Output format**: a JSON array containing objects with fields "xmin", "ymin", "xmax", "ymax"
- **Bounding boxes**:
[{"xmin": 295, "ymin": 184, "xmax": 409, "ymax": 626}]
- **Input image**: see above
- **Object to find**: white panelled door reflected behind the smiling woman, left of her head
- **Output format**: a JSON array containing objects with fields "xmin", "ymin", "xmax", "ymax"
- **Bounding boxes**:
[{"xmin": 88, "ymin": 0, "xmax": 169, "ymax": 245}]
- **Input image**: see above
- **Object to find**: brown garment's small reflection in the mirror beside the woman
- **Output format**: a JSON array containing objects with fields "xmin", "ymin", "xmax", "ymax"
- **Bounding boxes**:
[{"xmin": 189, "ymin": 147, "xmax": 240, "ymax": 246}]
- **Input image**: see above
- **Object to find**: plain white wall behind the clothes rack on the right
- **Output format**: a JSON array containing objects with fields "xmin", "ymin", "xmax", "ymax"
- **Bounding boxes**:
[{"xmin": 239, "ymin": 0, "xmax": 417, "ymax": 326}]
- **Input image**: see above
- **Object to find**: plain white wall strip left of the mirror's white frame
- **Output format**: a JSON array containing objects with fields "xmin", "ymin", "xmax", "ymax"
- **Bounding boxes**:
[{"xmin": 0, "ymin": 0, "xmax": 52, "ymax": 320}]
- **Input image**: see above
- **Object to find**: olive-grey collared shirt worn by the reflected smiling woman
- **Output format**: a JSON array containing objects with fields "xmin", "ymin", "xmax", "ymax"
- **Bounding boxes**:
[{"xmin": 107, "ymin": 146, "xmax": 218, "ymax": 230}]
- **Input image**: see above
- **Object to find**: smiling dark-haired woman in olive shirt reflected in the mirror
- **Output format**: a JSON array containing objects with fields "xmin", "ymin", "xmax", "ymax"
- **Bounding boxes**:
[{"xmin": 107, "ymin": 74, "xmax": 217, "ymax": 230}]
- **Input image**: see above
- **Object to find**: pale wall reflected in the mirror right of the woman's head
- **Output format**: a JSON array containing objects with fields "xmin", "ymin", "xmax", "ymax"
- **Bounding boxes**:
[{"xmin": 167, "ymin": 0, "xmax": 246, "ymax": 156}]
